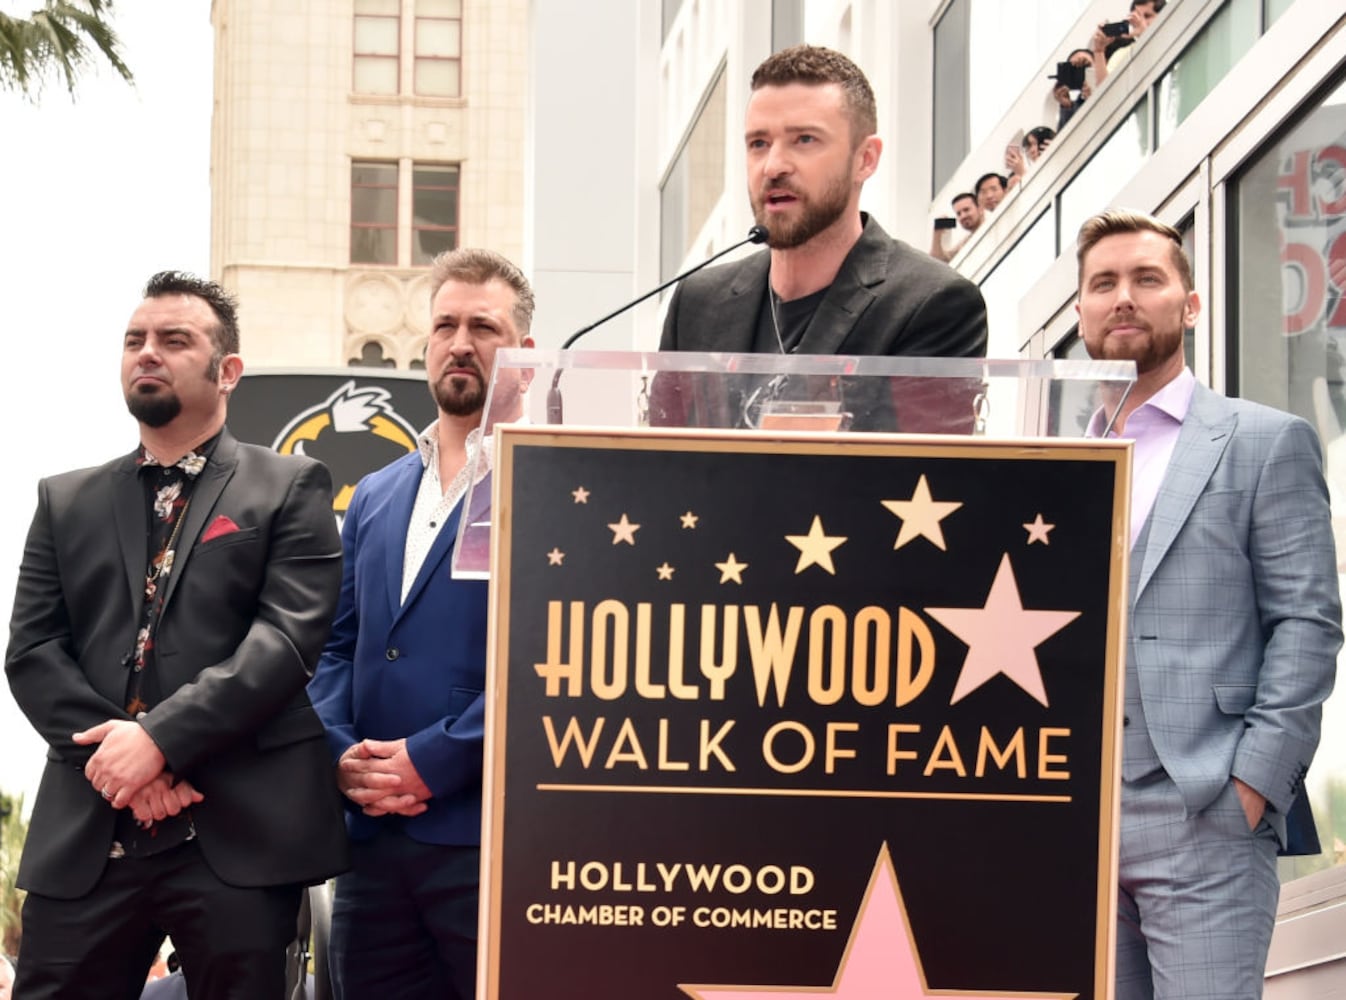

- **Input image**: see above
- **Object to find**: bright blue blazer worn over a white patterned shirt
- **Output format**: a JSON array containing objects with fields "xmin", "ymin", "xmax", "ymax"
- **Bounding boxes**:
[{"xmin": 308, "ymin": 452, "xmax": 487, "ymax": 845}]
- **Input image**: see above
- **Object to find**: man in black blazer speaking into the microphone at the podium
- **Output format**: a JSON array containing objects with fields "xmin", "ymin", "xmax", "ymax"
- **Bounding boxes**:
[{"xmin": 660, "ymin": 46, "xmax": 987, "ymax": 357}]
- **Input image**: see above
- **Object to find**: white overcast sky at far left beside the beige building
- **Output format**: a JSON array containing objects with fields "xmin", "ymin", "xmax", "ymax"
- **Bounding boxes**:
[{"xmin": 0, "ymin": 0, "xmax": 213, "ymax": 808}]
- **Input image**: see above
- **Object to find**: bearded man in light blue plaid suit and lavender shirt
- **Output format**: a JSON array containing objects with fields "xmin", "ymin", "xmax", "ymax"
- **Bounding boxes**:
[{"xmin": 1075, "ymin": 211, "xmax": 1342, "ymax": 1000}]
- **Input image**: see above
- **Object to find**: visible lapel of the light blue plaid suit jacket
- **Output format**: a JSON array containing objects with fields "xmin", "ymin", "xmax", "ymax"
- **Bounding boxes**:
[{"xmin": 1136, "ymin": 384, "xmax": 1237, "ymax": 598}]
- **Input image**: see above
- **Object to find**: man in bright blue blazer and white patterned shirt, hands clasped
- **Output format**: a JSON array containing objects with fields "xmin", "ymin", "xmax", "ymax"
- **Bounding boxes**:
[{"xmin": 310, "ymin": 249, "xmax": 533, "ymax": 1000}]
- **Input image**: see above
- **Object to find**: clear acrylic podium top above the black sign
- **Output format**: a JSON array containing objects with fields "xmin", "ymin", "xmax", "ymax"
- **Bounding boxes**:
[{"xmin": 452, "ymin": 349, "xmax": 1136, "ymax": 579}]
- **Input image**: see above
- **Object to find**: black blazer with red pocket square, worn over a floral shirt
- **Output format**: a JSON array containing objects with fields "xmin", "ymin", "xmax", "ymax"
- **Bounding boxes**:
[{"xmin": 5, "ymin": 431, "xmax": 346, "ymax": 899}]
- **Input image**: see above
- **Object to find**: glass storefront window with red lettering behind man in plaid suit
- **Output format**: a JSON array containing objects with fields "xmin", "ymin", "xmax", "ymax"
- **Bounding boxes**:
[{"xmin": 1230, "ymin": 74, "xmax": 1346, "ymax": 878}]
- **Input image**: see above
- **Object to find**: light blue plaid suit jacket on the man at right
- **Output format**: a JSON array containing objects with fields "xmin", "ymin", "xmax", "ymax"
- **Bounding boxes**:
[{"xmin": 1128, "ymin": 385, "xmax": 1342, "ymax": 845}]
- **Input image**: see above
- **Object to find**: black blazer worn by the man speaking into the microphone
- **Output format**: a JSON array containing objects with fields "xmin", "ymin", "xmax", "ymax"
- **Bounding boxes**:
[{"xmin": 660, "ymin": 213, "xmax": 987, "ymax": 358}]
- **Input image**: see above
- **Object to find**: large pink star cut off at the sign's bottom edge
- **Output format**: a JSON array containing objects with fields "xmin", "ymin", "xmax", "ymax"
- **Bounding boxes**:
[{"xmin": 678, "ymin": 844, "xmax": 1078, "ymax": 1000}]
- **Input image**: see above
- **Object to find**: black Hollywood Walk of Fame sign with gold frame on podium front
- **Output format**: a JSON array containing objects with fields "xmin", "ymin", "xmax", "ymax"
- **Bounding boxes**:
[{"xmin": 483, "ymin": 427, "xmax": 1128, "ymax": 1000}]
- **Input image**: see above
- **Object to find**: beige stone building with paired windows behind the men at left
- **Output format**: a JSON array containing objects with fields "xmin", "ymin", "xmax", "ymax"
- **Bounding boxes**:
[{"xmin": 211, "ymin": 0, "xmax": 528, "ymax": 369}]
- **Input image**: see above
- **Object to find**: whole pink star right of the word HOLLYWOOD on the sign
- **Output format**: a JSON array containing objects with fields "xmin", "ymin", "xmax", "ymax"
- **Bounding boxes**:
[{"xmin": 926, "ymin": 552, "xmax": 1079, "ymax": 705}]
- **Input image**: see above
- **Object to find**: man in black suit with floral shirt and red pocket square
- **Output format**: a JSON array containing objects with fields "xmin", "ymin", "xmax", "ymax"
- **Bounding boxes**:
[{"xmin": 5, "ymin": 272, "xmax": 346, "ymax": 1000}]
